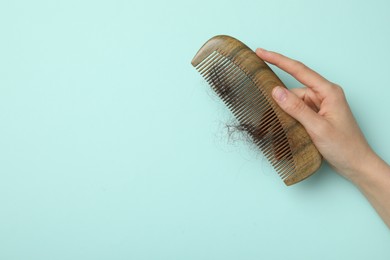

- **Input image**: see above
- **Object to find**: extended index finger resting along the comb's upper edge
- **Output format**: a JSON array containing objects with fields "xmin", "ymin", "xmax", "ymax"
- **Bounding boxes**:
[{"xmin": 256, "ymin": 48, "xmax": 332, "ymax": 96}]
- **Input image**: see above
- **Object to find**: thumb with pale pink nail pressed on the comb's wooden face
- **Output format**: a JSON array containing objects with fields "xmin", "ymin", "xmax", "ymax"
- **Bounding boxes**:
[{"xmin": 272, "ymin": 87, "xmax": 321, "ymax": 130}]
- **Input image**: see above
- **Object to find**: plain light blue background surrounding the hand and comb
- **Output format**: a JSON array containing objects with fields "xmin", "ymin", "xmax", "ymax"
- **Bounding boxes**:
[{"xmin": 0, "ymin": 0, "xmax": 390, "ymax": 260}]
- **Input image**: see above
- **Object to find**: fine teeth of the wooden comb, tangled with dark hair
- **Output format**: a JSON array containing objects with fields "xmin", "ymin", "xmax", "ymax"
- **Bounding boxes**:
[{"xmin": 195, "ymin": 51, "xmax": 296, "ymax": 180}]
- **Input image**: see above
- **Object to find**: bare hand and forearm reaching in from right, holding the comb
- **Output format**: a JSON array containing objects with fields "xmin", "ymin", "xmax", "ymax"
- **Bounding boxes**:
[{"xmin": 256, "ymin": 48, "xmax": 390, "ymax": 228}]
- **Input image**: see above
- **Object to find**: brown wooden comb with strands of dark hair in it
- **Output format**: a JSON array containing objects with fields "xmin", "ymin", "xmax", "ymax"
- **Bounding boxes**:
[{"xmin": 191, "ymin": 35, "xmax": 322, "ymax": 185}]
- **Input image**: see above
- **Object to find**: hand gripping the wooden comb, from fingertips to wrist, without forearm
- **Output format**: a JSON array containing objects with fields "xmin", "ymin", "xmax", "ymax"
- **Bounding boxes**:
[{"xmin": 256, "ymin": 49, "xmax": 377, "ymax": 183}]
